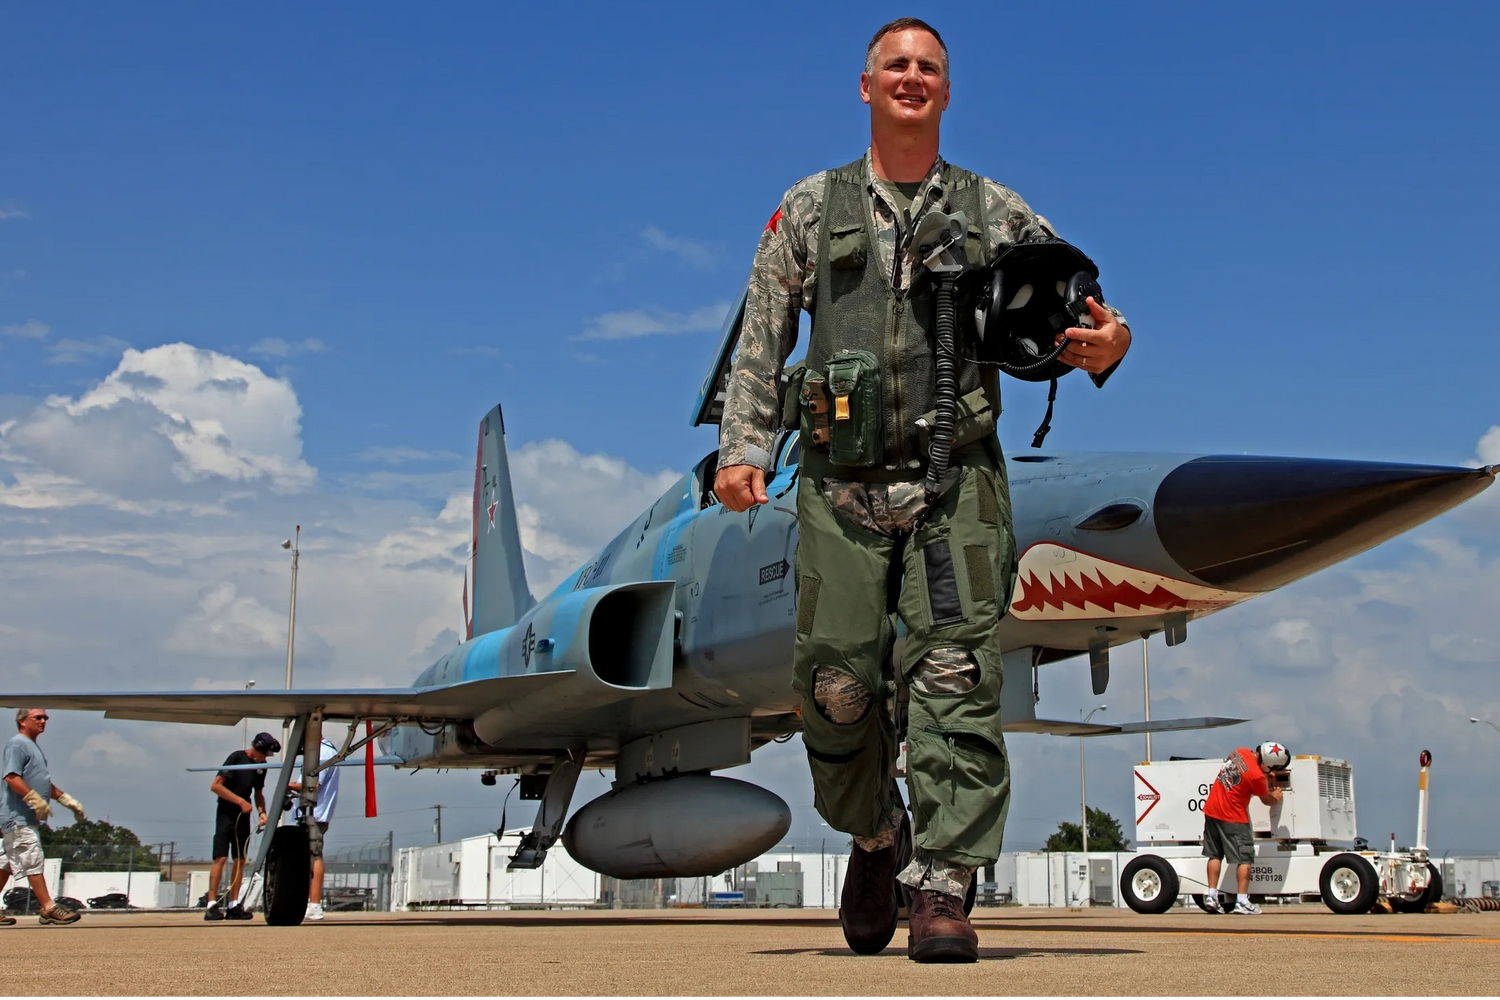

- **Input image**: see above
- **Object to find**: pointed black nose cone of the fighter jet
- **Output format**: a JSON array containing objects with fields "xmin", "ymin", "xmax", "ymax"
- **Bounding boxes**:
[{"xmin": 1152, "ymin": 456, "xmax": 1496, "ymax": 591}]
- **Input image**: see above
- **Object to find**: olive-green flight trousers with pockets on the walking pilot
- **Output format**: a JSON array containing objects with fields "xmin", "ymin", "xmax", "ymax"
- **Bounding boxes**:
[{"xmin": 794, "ymin": 447, "xmax": 1016, "ymax": 894}]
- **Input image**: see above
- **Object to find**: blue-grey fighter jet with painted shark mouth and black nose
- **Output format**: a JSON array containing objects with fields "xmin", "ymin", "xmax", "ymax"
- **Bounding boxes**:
[{"xmin": 0, "ymin": 301, "xmax": 1496, "ymax": 924}]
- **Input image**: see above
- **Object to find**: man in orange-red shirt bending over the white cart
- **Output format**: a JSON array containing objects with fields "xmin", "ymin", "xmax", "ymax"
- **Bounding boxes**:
[{"xmin": 1203, "ymin": 744, "xmax": 1292, "ymax": 913}]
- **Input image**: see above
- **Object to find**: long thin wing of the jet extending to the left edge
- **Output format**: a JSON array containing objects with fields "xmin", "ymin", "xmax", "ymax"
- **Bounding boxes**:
[{"xmin": 0, "ymin": 670, "xmax": 573, "ymax": 726}]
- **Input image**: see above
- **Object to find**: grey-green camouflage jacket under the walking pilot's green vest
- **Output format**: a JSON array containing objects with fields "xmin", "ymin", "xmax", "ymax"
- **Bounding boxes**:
[{"xmin": 719, "ymin": 150, "xmax": 1125, "ymax": 469}]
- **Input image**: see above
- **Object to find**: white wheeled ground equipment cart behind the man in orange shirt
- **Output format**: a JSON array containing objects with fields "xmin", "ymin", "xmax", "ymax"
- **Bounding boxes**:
[{"xmin": 1121, "ymin": 750, "xmax": 1443, "ymax": 913}]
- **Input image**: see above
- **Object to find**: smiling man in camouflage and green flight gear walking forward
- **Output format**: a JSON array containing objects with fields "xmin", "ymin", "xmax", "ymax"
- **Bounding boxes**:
[{"xmin": 714, "ymin": 18, "xmax": 1130, "ymax": 961}]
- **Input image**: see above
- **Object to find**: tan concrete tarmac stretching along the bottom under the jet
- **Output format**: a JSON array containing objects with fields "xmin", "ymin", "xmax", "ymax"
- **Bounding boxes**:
[{"xmin": 11, "ymin": 906, "xmax": 1500, "ymax": 997}]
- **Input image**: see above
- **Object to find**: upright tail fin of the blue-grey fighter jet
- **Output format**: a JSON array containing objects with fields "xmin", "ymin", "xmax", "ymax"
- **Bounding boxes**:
[{"xmin": 464, "ymin": 406, "xmax": 537, "ymax": 639}]
